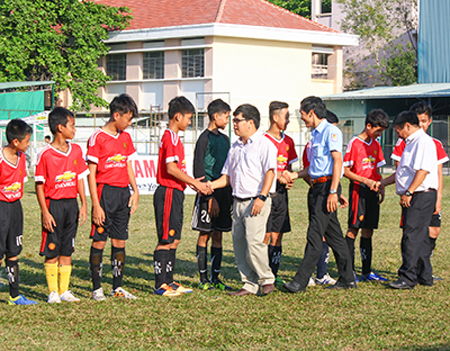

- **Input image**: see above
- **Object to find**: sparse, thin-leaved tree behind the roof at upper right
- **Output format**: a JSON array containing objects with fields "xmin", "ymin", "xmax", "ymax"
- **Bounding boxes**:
[{"xmin": 337, "ymin": 0, "xmax": 417, "ymax": 89}]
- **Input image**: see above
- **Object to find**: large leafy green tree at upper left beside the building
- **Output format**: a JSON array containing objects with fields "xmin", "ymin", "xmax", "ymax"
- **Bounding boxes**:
[{"xmin": 0, "ymin": 0, "xmax": 132, "ymax": 110}]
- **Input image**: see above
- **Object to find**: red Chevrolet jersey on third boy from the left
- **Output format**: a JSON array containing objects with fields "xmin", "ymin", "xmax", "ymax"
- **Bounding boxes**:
[{"xmin": 87, "ymin": 129, "xmax": 137, "ymax": 188}]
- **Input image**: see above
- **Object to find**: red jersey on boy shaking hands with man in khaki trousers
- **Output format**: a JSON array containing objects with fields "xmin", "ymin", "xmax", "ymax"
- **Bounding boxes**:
[{"xmin": 156, "ymin": 129, "xmax": 187, "ymax": 191}]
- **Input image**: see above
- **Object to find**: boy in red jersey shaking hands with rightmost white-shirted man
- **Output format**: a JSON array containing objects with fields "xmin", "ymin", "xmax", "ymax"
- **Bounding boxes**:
[{"xmin": 344, "ymin": 109, "xmax": 389, "ymax": 281}]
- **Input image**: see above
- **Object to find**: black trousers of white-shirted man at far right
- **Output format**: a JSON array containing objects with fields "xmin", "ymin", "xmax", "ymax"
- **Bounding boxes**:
[{"xmin": 398, "ymin": 191, "xmax": 436, "ymax": 286}]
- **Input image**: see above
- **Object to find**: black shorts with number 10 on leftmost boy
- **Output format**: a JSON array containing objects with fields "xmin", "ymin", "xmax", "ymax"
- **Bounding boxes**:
[{"xmin": 0, "ymin": 200, "xmax": 23, "ymax": 260}]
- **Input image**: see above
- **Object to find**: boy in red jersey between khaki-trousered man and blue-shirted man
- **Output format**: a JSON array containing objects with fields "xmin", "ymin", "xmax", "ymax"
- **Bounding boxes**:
[{"xmin": 264, "ymin": 101, "xmax": 298, "ymax": 287}]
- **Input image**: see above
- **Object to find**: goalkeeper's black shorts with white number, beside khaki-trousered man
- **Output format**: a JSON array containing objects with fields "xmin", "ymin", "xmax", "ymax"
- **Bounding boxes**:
[{"xmin": 192, "ymin": 186, "xmax": 233, "ymax": 233}]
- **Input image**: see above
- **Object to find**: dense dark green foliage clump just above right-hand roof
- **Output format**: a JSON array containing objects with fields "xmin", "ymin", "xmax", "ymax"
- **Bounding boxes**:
[{"xmin": 385, "ymin": 43, "xmax": 417, "ymax": 86}]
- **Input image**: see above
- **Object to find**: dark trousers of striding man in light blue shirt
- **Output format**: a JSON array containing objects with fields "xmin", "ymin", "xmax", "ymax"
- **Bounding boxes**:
[{"xmin": 294, "ymin": 180, "xmax": 355, "ymax": 289}]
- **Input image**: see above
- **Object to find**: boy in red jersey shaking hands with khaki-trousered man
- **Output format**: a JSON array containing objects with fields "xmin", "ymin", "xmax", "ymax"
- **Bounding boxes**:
[{"xmin": 153, "ymin": 96, "xmax": 210, "ymax": 296}]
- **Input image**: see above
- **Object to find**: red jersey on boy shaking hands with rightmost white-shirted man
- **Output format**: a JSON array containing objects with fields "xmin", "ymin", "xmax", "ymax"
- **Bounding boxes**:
[{"xmin": 344, "ymin": 137, "xmax": 386, "ymax": 181}]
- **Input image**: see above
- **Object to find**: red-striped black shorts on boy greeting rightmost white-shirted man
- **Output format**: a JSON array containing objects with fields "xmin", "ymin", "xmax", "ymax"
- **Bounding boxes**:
[{"xmin": 348, "ymin": 182, "xmax": 380, "ymax": 229}]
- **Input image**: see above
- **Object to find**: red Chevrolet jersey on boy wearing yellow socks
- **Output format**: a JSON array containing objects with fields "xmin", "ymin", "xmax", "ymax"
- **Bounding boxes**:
[{"xmin": 34, "ymin": 142, "xmax": 89, "ymax": 200}]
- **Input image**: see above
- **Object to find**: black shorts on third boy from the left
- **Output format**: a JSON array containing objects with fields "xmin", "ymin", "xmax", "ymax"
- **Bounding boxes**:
[{"xmin": 91, "ymin": 184, "xmax": 130, "ymax": 241}]
